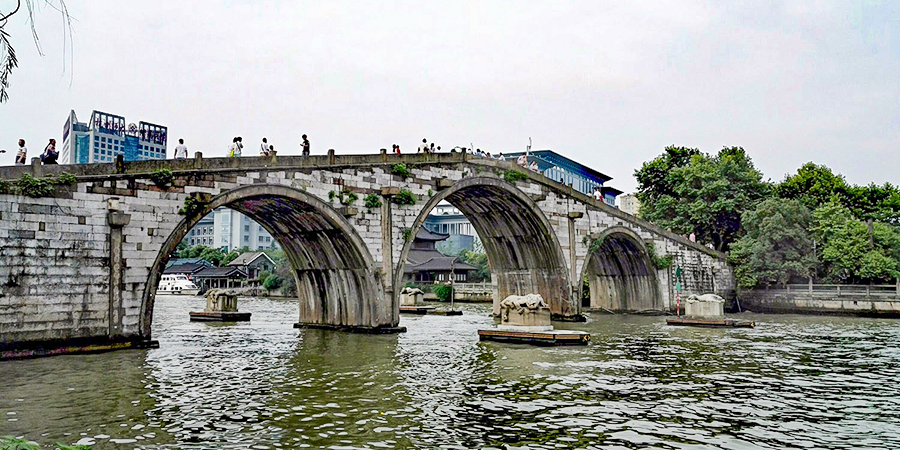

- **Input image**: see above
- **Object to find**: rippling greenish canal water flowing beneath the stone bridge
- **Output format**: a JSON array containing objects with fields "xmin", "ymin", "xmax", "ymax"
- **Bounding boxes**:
[{"xmin": 0, "ymin": 297, "xmax": 900, "ymax": 450}]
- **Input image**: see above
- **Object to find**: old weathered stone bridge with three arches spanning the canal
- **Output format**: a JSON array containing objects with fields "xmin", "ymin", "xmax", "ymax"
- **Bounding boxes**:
[{"xmin": 0, "ymin": 151, "xmax": 734, "ymax": 355}]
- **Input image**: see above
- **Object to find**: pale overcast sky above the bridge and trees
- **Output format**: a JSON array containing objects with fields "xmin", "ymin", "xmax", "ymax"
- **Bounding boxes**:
[{"xmin": 0, "ymin": 0, "xmax": 900, "ymax": 192}]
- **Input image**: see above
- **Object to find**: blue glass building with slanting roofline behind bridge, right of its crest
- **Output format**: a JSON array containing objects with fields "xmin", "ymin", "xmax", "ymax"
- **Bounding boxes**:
[{"xmin": 504, "ymin": 150, "xmax": 622, "ymax": 207}]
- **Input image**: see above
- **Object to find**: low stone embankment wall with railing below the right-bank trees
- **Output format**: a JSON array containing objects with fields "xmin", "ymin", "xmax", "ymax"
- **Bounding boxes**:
[{"xmin": 729, "ymin": 285, "xmax": 900, "ymax": 317}]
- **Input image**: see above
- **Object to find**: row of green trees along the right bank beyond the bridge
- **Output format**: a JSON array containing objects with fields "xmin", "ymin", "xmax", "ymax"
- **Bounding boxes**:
[{"xmin": 634, "ymin": 146, "xmax": 900, "ymax": 288}]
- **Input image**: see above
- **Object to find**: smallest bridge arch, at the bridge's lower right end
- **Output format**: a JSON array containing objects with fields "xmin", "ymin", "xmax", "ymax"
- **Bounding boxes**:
[{"xmin": 579, "ymin": 226, "xmax": 664, "ymax": 311}]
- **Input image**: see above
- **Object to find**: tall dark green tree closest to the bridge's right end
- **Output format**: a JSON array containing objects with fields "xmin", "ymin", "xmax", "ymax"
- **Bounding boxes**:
[{"xmin": 635, "ymin": 147, "xmax": 771, "ymax": 251}]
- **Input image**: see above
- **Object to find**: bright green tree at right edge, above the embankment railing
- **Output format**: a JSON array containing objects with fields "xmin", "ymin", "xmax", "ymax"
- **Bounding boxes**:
[{"xmin": 811, "ymin": 202, "xmax": 900, "ymax": 283}]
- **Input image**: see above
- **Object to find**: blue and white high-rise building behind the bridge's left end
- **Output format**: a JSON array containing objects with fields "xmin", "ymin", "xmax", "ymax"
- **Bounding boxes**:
[{"xmin": 59, "ymin": 110, "xmax": 168, "ymax": 164}]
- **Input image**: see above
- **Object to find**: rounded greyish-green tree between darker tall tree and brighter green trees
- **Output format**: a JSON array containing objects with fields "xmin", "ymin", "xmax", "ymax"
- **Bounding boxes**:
[{"xmin": 729, "ymin": 198, "xmax": 816, "ymax": 288}]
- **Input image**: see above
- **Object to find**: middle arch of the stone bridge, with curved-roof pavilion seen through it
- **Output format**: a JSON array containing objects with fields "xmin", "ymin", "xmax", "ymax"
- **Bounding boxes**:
[{"xmin": 394, "ymin": 176, "xmax": 580, "ymax": 316}]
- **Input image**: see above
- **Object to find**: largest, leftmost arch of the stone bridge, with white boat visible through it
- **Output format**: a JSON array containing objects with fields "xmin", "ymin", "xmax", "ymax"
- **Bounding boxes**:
[{"xmin": 140, "ymin": 184, "xmax": 390, "ymax": 337}]
